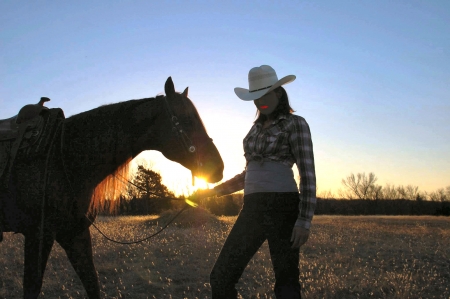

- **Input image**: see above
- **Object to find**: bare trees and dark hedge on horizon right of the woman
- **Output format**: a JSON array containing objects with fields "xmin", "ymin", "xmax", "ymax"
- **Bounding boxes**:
[{"xmin": 315, "ymin": 172, "xmax": 450, "ymax": 216}]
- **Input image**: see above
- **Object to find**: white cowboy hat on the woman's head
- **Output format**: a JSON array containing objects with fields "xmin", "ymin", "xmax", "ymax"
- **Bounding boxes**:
[{"xmin": 234, "ymin": 65, "xmax": 295, "ymax": 101}]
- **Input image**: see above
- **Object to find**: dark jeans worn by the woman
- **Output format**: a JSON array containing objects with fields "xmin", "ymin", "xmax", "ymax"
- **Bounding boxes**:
[{"xmin": 210, "ymin": 192, "xmax": 301, "ymax": 299}]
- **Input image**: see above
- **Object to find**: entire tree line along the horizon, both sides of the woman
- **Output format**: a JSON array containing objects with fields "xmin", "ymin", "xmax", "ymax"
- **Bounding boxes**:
[{"xmin": 101, "ymin": 165, "xmax": 450, "ymax": 216}]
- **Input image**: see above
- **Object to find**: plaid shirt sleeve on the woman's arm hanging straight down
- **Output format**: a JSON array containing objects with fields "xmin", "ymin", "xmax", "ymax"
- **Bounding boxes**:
[{"xmin": 289, "ymin": 117, "xmax": 317, "ymax": 229}]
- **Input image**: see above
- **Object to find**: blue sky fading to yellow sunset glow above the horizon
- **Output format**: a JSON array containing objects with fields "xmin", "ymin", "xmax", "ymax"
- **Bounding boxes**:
[{"xmin": 0, "ymin": 0, "xmax": 450, "ymax": 197}]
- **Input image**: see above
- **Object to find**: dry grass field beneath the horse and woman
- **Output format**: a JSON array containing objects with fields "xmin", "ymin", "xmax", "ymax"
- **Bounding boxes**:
[{"xmin": 0, "ymin": 211, "xmax": 450, "ymax": 299}]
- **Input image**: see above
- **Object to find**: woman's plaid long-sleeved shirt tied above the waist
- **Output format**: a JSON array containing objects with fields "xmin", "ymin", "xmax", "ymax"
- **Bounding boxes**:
[{"xmin": 214, "ymin": 114, "xmax": 316, "ymax": 229}]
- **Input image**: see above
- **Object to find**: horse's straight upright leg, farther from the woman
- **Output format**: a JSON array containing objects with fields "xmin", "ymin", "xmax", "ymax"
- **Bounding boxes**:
[{"xmin": 23, "ymin": 232, "xmax": 54, "ymax": 299}]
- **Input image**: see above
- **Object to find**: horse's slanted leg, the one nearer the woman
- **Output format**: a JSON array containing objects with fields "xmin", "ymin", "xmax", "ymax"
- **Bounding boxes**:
[{"xmin": 56, "ymin": 228, "xmax": 100, "ymax": 299}]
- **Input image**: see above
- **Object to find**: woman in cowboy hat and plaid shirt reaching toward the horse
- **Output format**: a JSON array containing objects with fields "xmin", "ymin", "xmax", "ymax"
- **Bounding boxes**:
[{"xmin": 199, "ymin": 65, "xmax": 316, "ymax": 299}]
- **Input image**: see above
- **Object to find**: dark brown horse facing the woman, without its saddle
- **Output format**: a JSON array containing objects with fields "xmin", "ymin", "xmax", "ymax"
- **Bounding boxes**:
[{"xmin": 0, "ymin": 77, "xmax": 224, "ymax": 299}]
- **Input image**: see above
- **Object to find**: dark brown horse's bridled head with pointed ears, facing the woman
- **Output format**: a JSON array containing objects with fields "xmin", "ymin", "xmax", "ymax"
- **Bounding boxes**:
[{"xmin": 130, "ymin": 77, "xmax": 224, "ymax": 183}]
